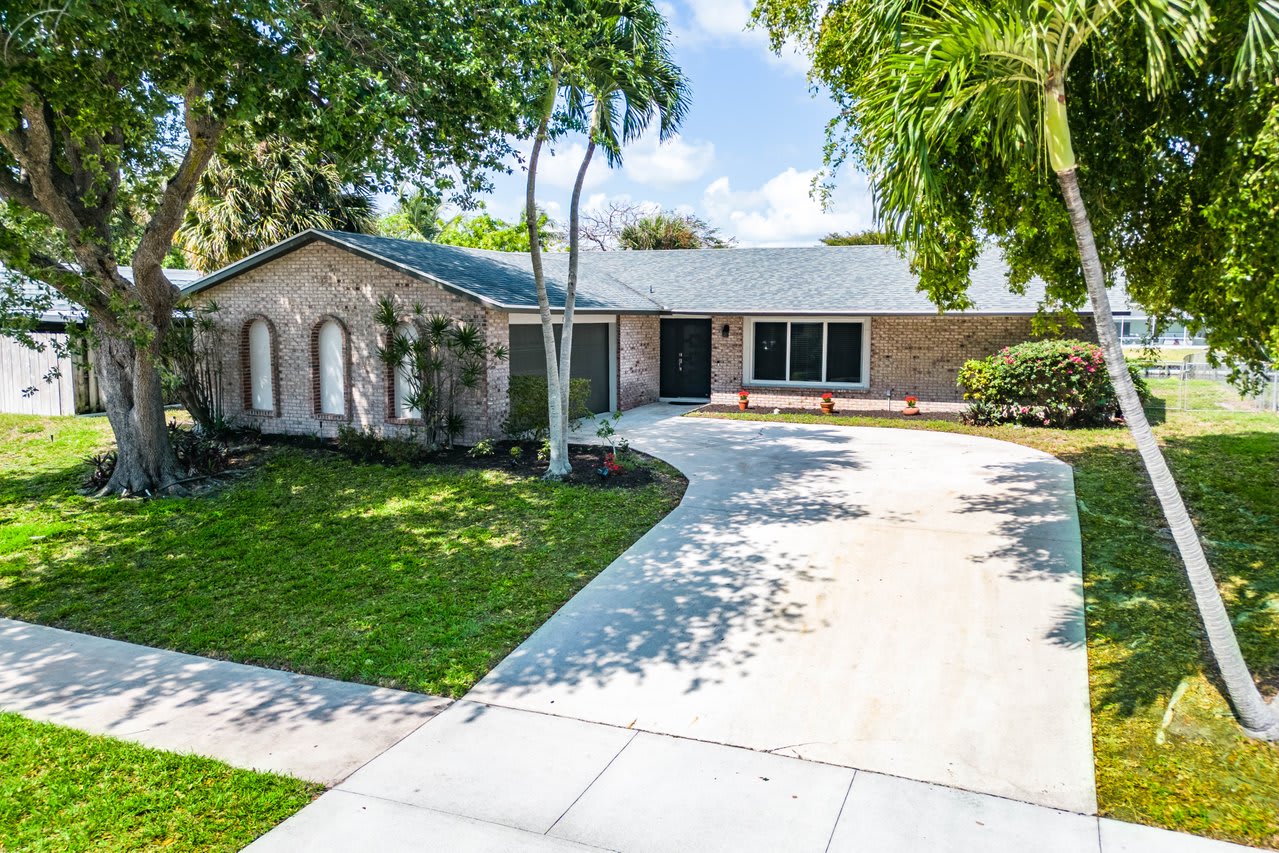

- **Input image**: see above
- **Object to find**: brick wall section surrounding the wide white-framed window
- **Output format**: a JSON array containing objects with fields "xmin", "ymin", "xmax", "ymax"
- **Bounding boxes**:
[{"xmin": 711, "ymin": 315, "xmax": 1096, "ymax": 409}]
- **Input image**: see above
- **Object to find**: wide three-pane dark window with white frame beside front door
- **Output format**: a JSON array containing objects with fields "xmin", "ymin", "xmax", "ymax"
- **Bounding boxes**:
[{"xmin": 746, "ymin": 317, "xmax": 870, "ymax": 387}]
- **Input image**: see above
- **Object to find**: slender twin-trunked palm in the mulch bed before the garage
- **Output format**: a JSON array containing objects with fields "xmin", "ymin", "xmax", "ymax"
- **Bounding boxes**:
[{"xmin": 526, "ymin": 0, "xmax": 689, "ymax": 478}]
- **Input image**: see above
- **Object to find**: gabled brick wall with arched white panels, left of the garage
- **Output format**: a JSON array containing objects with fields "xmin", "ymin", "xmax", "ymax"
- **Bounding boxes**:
[{"xmin": 194, "ymin": 236, "xmax": 509, "ymax": 444}]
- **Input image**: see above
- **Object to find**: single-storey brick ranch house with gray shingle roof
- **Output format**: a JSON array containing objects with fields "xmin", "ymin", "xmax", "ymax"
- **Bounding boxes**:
[{"xmin": 185, "ymin": 230, "xmax": 1095, "ymax": 442}]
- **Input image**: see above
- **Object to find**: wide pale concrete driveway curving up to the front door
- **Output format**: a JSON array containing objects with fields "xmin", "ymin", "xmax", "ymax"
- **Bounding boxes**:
[{"xmin": 467, "ymin": 405, "xmax": 1096, "ymax": 813}]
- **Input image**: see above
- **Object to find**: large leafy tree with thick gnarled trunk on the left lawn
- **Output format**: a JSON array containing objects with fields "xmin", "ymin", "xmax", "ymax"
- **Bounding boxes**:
[{"xmin": 0, "ymin": 0, "xmax": 531, "ymax": 492}]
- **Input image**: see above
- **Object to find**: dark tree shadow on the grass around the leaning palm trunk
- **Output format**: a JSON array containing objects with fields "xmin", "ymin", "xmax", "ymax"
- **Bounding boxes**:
[{"xmin": 1069, "ymin": 432, "xmax": 1279, "ymax": 715}]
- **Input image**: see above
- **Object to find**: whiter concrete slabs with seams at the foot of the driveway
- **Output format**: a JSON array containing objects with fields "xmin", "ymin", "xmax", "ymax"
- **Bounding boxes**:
[{"xmin": 248, "ymin": 700, "xmax": 1247, "ymax": 853}]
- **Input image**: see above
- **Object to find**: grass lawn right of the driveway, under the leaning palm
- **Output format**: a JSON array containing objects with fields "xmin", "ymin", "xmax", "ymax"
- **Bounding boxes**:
[{"xmin": 702, "ymin": 401, "xmax": 1279, "ymax": 847}]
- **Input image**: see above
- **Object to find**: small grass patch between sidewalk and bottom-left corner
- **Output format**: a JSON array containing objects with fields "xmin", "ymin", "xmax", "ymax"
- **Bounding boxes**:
[{"xmin": 0, "ymin": 714, "xmax": 320, "ymax": 853}]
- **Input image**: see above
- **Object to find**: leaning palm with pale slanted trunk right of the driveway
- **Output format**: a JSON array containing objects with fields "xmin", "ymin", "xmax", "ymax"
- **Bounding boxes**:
[{"xmin": 858, "ymin": 0, "xmax": 1279, "ymax": 740}]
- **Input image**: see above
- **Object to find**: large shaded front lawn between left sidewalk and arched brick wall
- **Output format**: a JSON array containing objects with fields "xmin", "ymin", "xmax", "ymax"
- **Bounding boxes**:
[{"xmin": 0, "ymin": 416, "xmax": 679, "ymax": 696}]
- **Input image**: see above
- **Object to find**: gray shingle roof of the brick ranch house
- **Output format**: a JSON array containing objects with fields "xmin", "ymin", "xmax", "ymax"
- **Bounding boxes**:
[{"xmin": 188, "ymin": 231, "xmax": 1089, "ymax": 315}]
